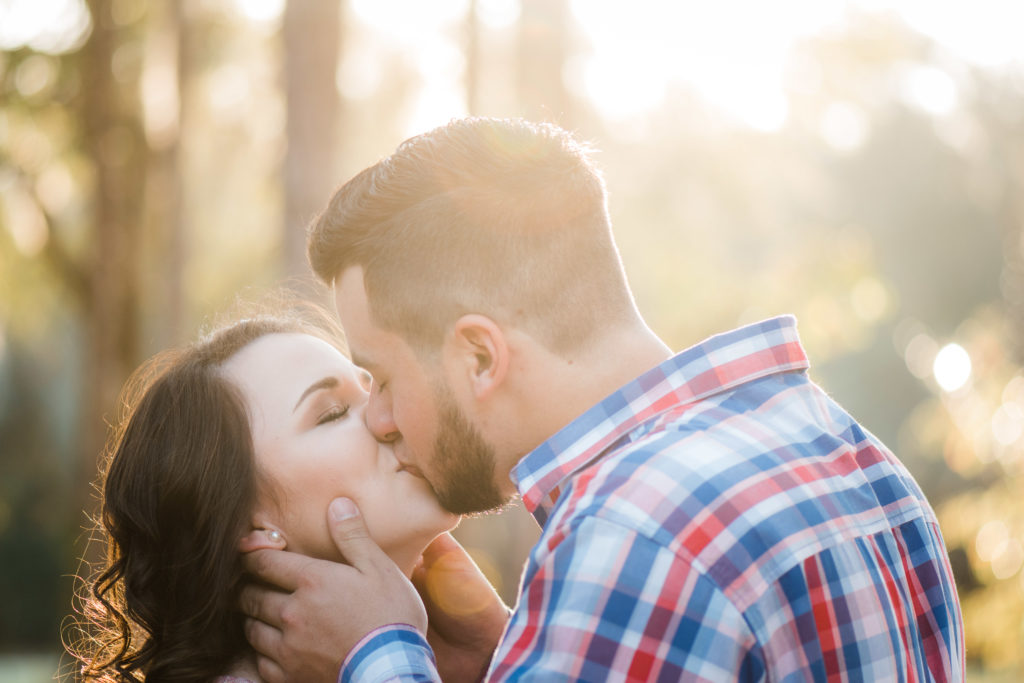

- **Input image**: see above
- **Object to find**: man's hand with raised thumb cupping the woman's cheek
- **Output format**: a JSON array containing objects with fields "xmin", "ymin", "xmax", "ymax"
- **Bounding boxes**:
[{"xmin": 240, "ymin": 499, "xmax": 427, "ymax": 683}]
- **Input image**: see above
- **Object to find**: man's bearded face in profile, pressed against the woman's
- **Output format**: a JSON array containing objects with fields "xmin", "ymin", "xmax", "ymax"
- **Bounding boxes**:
[{"xmin": 334, "ymin": 266, "xmax": 508, "ymax": 514}]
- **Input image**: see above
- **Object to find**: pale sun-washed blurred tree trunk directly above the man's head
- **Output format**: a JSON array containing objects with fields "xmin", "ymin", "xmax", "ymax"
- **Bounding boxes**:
[{"xmin": 518, "ymin": 0, "xmax": 575, "ymax": 128}]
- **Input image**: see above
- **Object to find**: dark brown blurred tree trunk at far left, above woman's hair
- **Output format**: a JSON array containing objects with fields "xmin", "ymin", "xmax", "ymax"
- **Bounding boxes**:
[{"xmin": 77, "ymin": 0, "xmax": 147, "ymax": 499}]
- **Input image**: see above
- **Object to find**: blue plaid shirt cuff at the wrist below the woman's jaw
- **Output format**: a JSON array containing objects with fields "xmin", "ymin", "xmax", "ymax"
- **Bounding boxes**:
[{"xmin": 338, "ymin": 624, "xmax": 440, "ymax": 683}]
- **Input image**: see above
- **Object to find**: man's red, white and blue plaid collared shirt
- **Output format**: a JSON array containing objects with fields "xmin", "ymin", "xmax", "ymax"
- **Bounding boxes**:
[{"xmin": 342, "ymin": 317, "xmax": 965, "ymax": 682}]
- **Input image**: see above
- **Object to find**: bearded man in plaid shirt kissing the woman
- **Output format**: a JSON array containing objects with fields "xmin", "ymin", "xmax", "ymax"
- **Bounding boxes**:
[{"xmin": 242, "ymin": 119, "xmax": 964, "ymax": 681}]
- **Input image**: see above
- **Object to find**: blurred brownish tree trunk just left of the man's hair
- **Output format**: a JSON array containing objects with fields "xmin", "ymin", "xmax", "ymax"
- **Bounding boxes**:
[{"xmin": 284, "ymin": 0, "xmax": 342, "ymax": 276}]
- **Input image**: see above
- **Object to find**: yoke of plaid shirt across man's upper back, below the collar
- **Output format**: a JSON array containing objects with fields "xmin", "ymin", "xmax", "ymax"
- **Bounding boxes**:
[{"xmin": 553, "ymin": 379, "xmax": 930, "ymax": 575}]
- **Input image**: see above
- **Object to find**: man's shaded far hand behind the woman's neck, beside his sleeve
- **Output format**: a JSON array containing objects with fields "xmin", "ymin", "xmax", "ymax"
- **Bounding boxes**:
[{"xmin": 413, "ymin": 533, "xmax": 509, "ymax": 683}]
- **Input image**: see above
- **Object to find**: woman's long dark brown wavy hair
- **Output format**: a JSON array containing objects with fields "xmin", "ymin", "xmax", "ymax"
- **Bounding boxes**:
[{"xmin": 69, "ymin": 306, "xmax": 346, "ymax": 683}]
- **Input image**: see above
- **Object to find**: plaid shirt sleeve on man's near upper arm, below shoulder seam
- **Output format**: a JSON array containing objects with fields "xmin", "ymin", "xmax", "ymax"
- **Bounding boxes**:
[{"xmin": 487, "ymin": 517, "xmax": 765, "ymax": 682}]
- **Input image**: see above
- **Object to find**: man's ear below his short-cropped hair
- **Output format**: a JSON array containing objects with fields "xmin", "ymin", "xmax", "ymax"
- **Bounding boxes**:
[{"xmin": 450, "ymin": 313, "xmax": 510, "ymax": 400}]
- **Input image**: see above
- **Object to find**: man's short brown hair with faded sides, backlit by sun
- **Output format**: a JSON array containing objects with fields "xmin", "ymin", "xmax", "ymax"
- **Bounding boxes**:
[{"xmin": 308, "ymin": 118, "xmax": 636, "ymax": 353}]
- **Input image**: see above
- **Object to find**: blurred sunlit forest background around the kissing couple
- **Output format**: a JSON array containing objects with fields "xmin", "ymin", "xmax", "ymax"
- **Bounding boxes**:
[{"xmin": 0, "ymin": 0, "xmax": 1024, "ymax": 683}]
